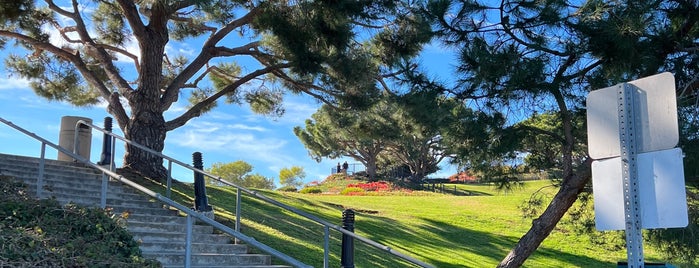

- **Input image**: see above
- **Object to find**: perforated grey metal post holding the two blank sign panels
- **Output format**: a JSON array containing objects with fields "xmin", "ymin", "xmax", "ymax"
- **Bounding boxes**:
[{"xmin": 617, "ymin": 83, "xmax": 644, "ymax": 268}]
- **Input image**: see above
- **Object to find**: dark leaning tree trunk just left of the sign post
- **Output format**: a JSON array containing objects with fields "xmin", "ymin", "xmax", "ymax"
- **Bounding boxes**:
[{"xmin": 497, "ymin": 158, "xmax": 592, "ymax": 267}]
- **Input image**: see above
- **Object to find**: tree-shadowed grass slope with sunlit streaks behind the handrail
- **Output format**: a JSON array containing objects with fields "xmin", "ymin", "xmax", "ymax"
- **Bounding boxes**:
[{"xmin": 120, "ymin": 175, "xmax": 611, "ymax": 267}]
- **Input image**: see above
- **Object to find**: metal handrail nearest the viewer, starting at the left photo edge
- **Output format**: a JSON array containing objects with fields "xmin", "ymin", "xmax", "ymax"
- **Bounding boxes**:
[{"xmin": 0, "ymin": 117, "xmax": 312, "ymax": 268}]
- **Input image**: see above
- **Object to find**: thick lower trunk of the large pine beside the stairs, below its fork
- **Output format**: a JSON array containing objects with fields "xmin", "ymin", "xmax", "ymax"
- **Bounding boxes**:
[{"xmin": 124, "ymin": 112, "xmax": 167, "ymax": 179}]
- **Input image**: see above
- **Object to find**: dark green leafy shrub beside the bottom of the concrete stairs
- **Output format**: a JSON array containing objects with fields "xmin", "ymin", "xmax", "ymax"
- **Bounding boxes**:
[{"xmin": 0, "ymin": 177, "xmax": 160, "ymax": 267}]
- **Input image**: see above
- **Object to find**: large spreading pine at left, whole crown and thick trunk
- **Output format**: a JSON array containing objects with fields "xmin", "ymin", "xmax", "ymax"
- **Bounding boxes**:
[{"xmin": 0, "ymin": 0, "xmax": 416, "ymax": 178}]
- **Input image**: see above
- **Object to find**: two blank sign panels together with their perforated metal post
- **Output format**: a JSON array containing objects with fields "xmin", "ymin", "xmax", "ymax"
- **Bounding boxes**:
[{"xmin": 587, "ymin": 73, "xmax": 689, "ymax": 268}]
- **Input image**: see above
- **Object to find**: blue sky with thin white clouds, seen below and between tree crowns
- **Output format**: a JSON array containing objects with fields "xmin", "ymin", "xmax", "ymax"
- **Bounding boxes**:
[{"xmin": 0, "ymin": 46, "xmax": 455, "ymax": 185}]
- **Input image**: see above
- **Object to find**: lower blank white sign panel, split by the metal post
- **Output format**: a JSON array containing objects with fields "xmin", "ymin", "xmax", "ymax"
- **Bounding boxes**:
[{"xmin": 592, "ymin": 148, "xmax": 688, "ymax": 231}]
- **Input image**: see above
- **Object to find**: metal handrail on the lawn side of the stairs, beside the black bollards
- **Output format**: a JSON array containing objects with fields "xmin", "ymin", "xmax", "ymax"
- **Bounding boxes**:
[{"xmin": 74, "ymin": 120, "xmax": 434, "ymax": 268}]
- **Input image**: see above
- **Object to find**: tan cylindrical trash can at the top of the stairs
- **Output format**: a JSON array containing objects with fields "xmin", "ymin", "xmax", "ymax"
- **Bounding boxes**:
[{"xmin": 58, "ymin": 116, "xmax": 92, "ymax": 161}]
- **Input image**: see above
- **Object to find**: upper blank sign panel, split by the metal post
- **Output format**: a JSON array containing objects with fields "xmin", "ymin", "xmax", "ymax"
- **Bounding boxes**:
[{"xmin": 587, "ymin": 73, "xmax": 679, "ymax": 159}]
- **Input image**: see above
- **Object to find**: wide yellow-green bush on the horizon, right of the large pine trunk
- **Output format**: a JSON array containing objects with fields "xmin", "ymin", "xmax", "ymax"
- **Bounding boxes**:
[{"xmin": 207, "ymin": 160, "xmax": 274, "ymax": 189}]
